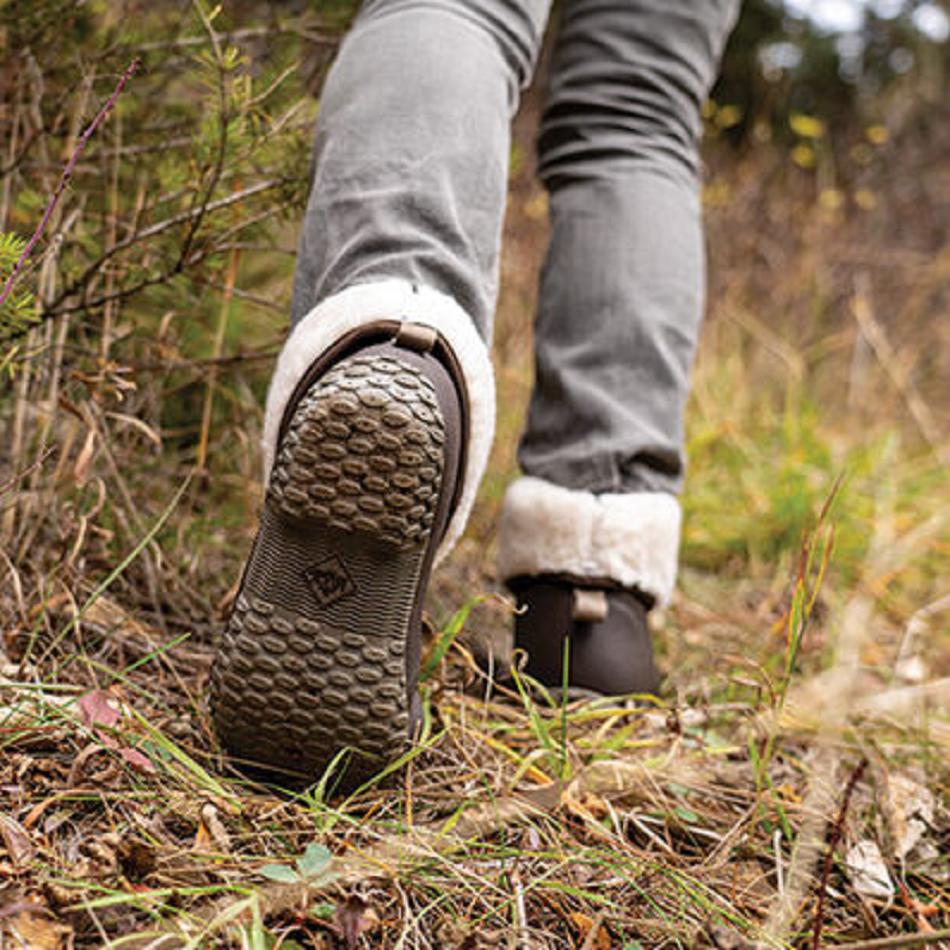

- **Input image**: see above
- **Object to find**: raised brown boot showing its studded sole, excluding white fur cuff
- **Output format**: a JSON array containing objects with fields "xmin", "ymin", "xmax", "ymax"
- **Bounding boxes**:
[{"xmin": 211, "ymin": 321, "xmax": 466, "ymax": 789}]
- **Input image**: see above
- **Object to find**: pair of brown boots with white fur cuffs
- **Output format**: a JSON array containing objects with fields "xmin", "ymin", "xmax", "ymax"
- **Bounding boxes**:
[{"xmin": 211, "ymin": 284, "xmax": 675, "ymax": 786}]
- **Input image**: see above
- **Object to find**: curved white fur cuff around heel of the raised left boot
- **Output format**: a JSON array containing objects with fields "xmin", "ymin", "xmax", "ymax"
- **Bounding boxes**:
[{"xmin": 263, "ymin": 279, "xmax": 495, "ymax": 561}]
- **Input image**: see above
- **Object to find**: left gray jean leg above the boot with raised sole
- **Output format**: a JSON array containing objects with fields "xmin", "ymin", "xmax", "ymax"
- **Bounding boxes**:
[{"xmin": 291, "ymin": 0, "xmax": 550, "ymax": 340}]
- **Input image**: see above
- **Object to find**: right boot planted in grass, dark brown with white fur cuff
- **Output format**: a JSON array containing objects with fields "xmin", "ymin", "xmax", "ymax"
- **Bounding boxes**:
[{"xmin": 499, "ymin": 477, "xmax": 680, "ymax": 695}]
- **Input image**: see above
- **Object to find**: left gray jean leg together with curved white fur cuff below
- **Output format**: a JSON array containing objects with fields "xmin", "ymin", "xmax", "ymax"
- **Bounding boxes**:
[{"xmin": 262, "ymin": 0, "xmax": 550, "ymax": 559}]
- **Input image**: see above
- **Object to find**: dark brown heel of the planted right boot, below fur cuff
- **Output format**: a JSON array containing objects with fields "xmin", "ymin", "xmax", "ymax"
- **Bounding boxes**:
[{"xmin": 508, "ymin": 576, "xmax": 660, "ymax": 696}]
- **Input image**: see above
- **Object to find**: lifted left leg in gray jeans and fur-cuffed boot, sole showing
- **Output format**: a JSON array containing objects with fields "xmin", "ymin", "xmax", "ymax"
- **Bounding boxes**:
[{"xmin": 211, "ymin": 0, "xmax": 547, "ymax": 784}]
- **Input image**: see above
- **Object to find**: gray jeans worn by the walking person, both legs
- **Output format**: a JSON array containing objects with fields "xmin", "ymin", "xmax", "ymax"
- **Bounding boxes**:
[{"xmin": 292, "ymin": 0, "xmax": 739, "ymax": 493}]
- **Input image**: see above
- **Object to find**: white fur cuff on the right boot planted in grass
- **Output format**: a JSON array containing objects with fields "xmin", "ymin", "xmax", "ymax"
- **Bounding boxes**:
[{"xmin": 498, "ymin": 478, "xmax": 680, "ymax": 604}]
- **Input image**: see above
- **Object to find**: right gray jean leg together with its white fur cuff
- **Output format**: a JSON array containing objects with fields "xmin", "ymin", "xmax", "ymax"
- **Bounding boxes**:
[{"xmin": 500, "ymin": 0, "xmax": 738, "ymax": 692}]
